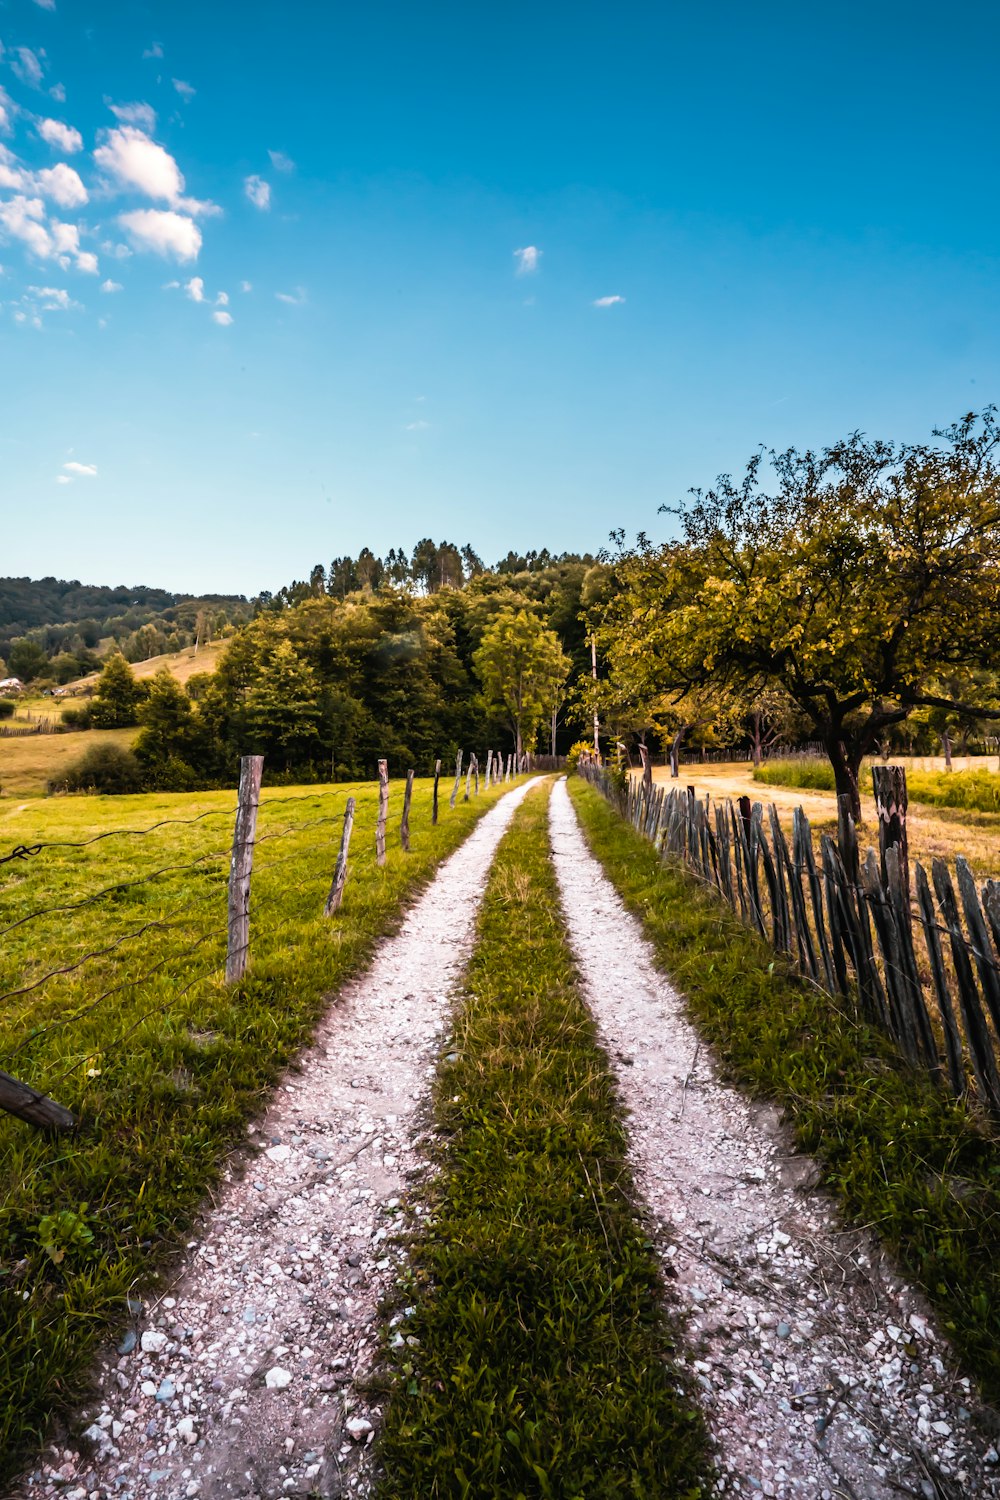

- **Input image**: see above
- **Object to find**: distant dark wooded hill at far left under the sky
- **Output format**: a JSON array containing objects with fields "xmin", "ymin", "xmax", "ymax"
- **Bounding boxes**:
[{"xmin": 0, "ymin": 578, "xmax": 253, "ymax": 683}]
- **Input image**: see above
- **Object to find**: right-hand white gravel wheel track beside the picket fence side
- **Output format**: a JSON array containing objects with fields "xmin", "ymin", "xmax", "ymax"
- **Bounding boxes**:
[{"xmin": 550, "ymin": 782, "xmax": 1000, "ymax": 1500}]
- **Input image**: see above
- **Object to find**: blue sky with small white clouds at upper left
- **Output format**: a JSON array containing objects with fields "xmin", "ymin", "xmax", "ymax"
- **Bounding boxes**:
[{"xmin": 0, "ymin": 0, "xmax": 1000, "ymax": 594}]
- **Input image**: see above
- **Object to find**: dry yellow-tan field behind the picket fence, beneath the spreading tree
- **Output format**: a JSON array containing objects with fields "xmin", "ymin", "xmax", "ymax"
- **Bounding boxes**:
[{"xmin": 641, "ymin": 756, "xmax": 1000, "ymax": 879}]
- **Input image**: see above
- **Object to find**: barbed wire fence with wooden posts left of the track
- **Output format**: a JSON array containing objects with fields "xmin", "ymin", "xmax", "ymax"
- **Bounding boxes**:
[{"xmin": 0, "ymin": 752, "xmax": 532, "ymax": 1131}]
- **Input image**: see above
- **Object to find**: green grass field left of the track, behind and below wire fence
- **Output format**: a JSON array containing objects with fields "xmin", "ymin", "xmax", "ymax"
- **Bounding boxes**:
[{"xmin": 0, "ymin": 782, "xmax": 515, "ymax": 1484}]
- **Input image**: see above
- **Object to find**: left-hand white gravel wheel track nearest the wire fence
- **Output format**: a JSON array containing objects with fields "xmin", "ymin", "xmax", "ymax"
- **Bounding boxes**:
[{"xmin": 15, "ymin": 783, "xmax": 531, "ymax": 1500}]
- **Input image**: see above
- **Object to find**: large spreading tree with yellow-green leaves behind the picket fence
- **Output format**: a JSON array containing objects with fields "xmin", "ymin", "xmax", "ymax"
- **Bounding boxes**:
[{"xmin": 603, "ymin": 408, "xmax": 1000, "ymax": 816}]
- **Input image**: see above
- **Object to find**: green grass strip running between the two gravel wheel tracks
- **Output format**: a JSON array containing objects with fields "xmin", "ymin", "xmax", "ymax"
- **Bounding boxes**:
[{"xmin": 376, "ymin": 792, "xmax": 709, "ymax": 1500}]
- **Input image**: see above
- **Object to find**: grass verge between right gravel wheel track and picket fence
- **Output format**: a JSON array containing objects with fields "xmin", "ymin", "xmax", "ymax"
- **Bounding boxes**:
[{"xmin": 570, "ymin": 777, "xmax": 1000, "ymax": 1403}]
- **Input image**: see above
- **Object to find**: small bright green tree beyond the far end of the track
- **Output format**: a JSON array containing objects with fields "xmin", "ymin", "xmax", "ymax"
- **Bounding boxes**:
[{"xmin": 472, "ymin": 609, "xmax": 571, "ymax": 755}]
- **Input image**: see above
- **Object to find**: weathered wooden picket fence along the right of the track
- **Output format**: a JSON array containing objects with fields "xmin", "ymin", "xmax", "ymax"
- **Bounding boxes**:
[{"xmin": 579, "ymin": 762, "xmax": 1000, "ymax": 1119}]
